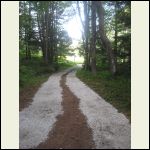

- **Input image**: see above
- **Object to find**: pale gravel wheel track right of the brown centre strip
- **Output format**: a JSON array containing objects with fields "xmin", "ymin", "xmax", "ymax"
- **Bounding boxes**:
[{"xmin": 66, "ymin": 69, "xmax": 131, "ymax": 149}]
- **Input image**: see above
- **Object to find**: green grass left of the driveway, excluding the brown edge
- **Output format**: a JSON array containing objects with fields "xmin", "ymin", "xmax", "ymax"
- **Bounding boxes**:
[{"xmin": 19, "ymin": 56, "xmax": 75, "ymax": 91}]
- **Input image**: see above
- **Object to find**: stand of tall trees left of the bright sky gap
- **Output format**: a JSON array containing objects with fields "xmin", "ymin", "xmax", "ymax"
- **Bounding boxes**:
[{"xmin": 19, "ymin": 1, "xmax": 71, "ymax": 64}]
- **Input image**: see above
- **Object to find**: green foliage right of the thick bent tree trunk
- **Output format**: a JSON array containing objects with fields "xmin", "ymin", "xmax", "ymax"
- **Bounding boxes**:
[{"xmin": 101, "ymin": 1, "xmax": 131, "ymax": 68}]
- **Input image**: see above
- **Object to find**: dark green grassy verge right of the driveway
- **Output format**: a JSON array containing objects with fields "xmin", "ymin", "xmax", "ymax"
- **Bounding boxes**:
[{"xmin": 77, "ymin": 69, "xmax": 131, "ymax": 121}]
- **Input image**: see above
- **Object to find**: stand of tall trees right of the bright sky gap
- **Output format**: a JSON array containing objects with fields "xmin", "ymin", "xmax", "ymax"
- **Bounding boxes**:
[{"xmin": 78, "ymin": 1, "xmax": 131, "ymax": 74}]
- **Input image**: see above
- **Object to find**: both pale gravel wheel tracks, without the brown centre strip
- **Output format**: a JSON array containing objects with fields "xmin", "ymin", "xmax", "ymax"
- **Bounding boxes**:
[{"xmin": 19, "ymin": 69, "xmax": 131, "ymax": 149}]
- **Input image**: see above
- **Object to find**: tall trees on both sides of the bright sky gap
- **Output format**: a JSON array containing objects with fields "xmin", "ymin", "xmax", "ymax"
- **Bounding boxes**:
[{"xmin": 19, "ymin": 1, "xmax": 131, "ymax": 74}]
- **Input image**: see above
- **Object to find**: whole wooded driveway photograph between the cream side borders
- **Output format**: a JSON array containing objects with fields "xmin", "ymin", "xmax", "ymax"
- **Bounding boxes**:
[{"xmin": 19, "ymin": 1, "xmax": 131, "ymax": 149}]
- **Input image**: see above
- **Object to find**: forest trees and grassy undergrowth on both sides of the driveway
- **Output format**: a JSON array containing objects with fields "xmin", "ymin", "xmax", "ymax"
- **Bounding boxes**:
[{"xmin": 19, "ymin": 1, "xmax": 131, "ymax": 119}]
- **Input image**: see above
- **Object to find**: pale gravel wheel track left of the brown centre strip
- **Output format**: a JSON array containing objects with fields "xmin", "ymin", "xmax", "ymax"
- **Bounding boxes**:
[{"xmin": 19, "ymin": 73, "xmax": 63, "ymax": 149}]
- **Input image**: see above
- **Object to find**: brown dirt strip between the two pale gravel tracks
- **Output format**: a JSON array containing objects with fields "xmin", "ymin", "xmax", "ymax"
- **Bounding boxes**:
[{"xmin": 36, "ymin": 74, "xmax": 95, "ymax": 149}]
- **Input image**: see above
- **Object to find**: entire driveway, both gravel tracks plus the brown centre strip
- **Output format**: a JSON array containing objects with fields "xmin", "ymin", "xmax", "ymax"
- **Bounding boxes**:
[{"xmin": 20, "ymin": 66, "xmax": 130, "ymax": 149}]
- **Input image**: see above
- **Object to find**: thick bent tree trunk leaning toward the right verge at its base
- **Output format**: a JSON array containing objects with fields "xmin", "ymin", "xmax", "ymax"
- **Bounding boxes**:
[{"xmin": 96, "ymin": 1, "xmax": 116, "ymax": 74}]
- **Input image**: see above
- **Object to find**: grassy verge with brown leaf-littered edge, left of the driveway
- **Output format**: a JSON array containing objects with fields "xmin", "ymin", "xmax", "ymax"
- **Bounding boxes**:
[{"xmin": 19, "ymin": 57, "xmax": 75, "ymax": 111}]
